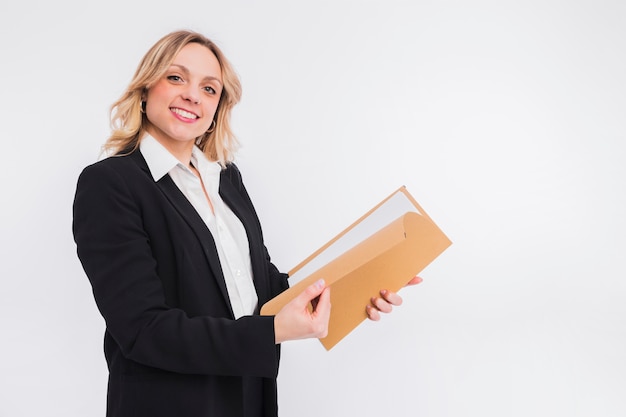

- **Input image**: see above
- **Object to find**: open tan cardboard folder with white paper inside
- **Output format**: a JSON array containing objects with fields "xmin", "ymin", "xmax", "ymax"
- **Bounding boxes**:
[{"xmin": 261, "ymin": 187, "xmax": 452, "ymax": 350}]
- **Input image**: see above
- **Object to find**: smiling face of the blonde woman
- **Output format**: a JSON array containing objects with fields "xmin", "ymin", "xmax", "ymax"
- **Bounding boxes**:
[{"xmin": 144, "ymin": 43, "xmax": 223, "ymax": 162}]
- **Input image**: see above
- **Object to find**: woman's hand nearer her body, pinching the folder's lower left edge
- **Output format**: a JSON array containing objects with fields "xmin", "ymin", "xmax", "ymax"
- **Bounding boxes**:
[{"xmin": 274, "ymin": 279, "xmax": 330, "ymax": 344}]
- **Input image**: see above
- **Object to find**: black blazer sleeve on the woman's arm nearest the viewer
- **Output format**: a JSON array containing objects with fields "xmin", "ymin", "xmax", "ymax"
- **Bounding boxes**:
[{"xmin": 73, "ymin": 163, "xmax": 278, "ymax": 378}]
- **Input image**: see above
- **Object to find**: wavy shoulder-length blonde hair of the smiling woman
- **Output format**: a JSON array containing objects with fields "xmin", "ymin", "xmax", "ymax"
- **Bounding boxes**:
[{"xmin": 103, "ymin": 30, "xmax": 241, "ymax": 166}]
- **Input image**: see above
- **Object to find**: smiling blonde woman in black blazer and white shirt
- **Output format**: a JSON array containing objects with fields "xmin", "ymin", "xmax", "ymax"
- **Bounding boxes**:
[{"xmin": 73, "ymin": 31, "xmax": 416, "ymax": 417}]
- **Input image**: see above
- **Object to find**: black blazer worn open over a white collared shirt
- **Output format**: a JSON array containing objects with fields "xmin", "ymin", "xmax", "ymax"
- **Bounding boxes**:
[{"xmin": 73, "ymin": 151, "xmax": 288, "ymax": 417}]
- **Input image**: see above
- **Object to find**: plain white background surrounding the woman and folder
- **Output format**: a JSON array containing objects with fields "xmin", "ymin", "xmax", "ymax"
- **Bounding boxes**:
[{"xmin": 0, "ymin": 0, "xmax": 626, "ymax": 417}]
